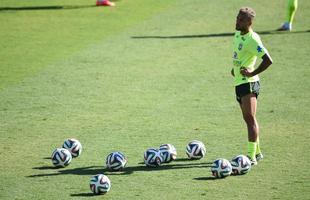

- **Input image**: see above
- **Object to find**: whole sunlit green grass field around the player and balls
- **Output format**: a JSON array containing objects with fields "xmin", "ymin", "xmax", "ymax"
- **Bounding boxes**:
[{"xmin": 0, "ymin": 0, "xmax": 310, "ymax": 200}]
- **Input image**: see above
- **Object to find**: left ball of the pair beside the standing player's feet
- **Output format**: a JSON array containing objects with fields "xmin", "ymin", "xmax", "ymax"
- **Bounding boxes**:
[{"xmin": 211, "ymin": 158, "xmax": 232, "ymax": 178}]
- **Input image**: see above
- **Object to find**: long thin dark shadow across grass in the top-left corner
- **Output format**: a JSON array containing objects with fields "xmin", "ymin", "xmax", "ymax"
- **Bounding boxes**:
[{"xmin": 0, "ymin": 5, "xmax": 96, "ymax": 12}]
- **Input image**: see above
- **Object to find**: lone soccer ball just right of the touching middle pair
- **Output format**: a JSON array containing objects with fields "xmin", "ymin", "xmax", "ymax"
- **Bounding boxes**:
[{"xmin": 186, "ymin": 140, "xmax": 206, "ymax": 159}]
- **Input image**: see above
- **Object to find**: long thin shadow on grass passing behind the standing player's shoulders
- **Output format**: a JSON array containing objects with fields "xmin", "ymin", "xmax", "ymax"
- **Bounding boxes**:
[{"xmin": 131, "ymin": 30, "xmax": 310, "ymax": 39}]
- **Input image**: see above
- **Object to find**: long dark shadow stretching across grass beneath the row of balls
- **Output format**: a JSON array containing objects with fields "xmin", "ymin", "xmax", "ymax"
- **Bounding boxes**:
[{"xmin": 27, "ymin": 158, "xmax": 212, "ymax": 178}]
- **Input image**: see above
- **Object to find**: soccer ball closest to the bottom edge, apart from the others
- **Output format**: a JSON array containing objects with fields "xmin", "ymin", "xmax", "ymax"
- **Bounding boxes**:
[{"xmin": 89, "ymin": 174, "xmax": 111, "ymax": 194}]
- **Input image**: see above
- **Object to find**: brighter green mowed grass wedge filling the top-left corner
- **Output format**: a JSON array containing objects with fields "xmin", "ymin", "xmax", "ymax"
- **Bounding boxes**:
[{"xmin": 0, "ymin": 0, "xmax": 175, "ymax": 88}]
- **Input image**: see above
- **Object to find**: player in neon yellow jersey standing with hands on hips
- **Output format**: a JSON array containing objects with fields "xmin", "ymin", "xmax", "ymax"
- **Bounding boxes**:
[{"xmin": 231, "ymin": 7, "xmax": 272, "ymax": 165}]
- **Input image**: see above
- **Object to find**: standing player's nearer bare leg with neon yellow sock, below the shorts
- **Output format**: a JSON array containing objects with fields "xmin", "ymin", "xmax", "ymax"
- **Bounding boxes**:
[{"xmin": 240, "ymin": 93, "xmax": 259, "ymax": 164}]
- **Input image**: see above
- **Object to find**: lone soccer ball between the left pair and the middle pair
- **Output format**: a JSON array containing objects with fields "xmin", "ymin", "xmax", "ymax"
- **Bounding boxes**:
[{"xmin": 106, "ymin": 151, "xmax": 127, "ymax": 171}]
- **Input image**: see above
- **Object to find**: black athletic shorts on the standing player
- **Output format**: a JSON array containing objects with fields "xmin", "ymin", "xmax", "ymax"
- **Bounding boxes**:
[{"xmin": 235, "ymin": 81, "xmax": 260, "ymax": 104}]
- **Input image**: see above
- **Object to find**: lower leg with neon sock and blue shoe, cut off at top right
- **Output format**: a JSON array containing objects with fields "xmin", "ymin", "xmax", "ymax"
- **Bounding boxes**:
[{"xmin": 277, "ymin": 0, "xmax": 298, "ymax": 31}]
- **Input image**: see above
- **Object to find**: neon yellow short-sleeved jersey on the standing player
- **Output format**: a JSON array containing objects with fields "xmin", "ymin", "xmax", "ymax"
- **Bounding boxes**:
[{"xmin": 233, "ymin": 30, "xmax": 268, "ymax": 86}]
